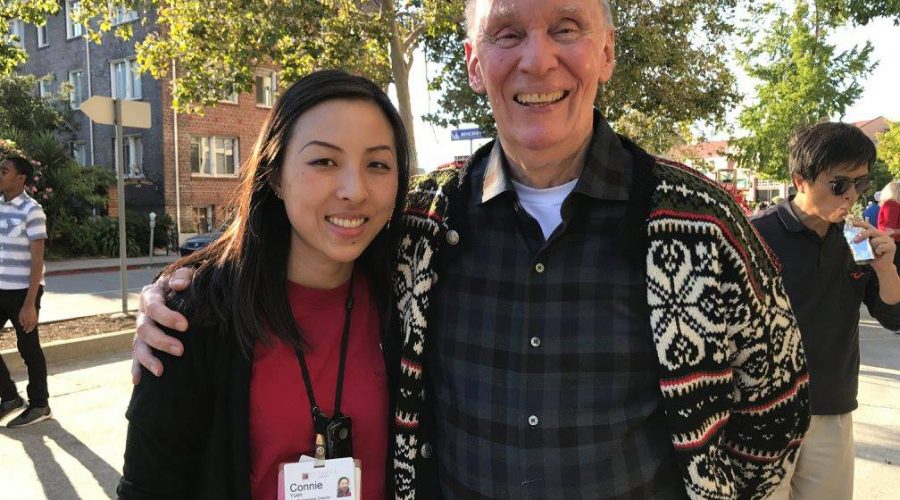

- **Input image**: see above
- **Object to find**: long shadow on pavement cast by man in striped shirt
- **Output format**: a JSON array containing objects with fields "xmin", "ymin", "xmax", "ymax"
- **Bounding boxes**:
[{"xmin": 0, "ymin": 419, "xmax": 120, "ymax": 498}]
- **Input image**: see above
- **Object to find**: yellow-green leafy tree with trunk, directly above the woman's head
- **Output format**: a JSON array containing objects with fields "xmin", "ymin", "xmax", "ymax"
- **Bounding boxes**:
[{"xmin": 79, "ymin": 0, "xmax": 461, "ymax": 172}]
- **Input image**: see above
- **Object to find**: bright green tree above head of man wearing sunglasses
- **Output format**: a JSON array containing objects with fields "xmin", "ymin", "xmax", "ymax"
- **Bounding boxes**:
[{"xmin": 732, "ymin": 0, "xmax": 875, "ymax": 180}]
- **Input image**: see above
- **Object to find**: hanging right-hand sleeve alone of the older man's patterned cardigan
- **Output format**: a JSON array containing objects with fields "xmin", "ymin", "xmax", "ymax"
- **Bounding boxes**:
[{"xmin": 720, "ymin": 213, "xmax": 809, "ymax": 498}]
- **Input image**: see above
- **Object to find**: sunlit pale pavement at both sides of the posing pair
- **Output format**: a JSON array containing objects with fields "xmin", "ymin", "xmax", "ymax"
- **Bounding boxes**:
[{"xmin": 0, "ymin": 322, "xmax": 900, "ymax": 500}]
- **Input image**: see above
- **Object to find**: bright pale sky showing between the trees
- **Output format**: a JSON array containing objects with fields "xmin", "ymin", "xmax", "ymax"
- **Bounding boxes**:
[{"xmin": 400, "ymin": 19, "xmax": 900, "ymax": 170}]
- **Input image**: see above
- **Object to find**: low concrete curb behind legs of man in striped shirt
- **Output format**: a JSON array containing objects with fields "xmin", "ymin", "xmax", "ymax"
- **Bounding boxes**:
[{"xmin": 0, "ymin": 329, "xmax": 135, "ymax": 371}]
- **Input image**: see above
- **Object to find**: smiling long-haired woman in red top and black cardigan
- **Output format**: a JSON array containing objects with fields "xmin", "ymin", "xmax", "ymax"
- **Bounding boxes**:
[{"xmin": 118, "ymin": 71, "xmax": 409, "ymax": 500}]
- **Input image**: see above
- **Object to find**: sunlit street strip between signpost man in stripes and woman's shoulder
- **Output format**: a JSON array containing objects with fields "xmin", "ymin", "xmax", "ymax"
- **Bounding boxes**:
[{"xmin": 40, "ymin": 266, "xmax": 163, "ymax": 323}]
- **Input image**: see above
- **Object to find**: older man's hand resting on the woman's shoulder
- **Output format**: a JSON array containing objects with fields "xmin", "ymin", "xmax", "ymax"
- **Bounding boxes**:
[{"xmin": 131, "ymin": 267, "xmax": 194, "ymax": 384}]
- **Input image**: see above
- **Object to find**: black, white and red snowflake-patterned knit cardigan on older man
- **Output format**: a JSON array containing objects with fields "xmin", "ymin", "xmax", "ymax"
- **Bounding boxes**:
[{"xmin": 393, "ymin": 138, "xmax": 809, "ymax": 500}]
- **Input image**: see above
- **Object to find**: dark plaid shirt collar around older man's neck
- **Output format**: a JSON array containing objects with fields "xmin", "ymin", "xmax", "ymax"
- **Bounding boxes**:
[{"xmin": 481, "ymin": 110, "xmax": 633, "ymax": 203}]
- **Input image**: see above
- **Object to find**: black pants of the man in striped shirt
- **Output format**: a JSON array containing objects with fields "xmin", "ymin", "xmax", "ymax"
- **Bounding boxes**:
[{"xmin": 0, "ymin": 286, "xmax": 49, "ymax": 406}]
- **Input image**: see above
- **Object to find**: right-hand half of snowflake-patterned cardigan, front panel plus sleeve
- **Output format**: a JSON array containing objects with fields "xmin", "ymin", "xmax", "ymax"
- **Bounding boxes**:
[{"xmin": 647, "ymin": 165, "xmax": 809, "ymax": 499}]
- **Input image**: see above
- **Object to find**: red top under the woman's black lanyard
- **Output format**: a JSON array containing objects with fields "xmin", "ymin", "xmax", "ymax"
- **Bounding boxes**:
[{"xmin": 250, "ymin": 275, "xmax": 388, "ymax": 500}]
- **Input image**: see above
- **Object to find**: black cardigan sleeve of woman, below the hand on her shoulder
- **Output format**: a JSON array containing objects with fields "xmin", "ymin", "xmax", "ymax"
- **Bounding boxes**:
[{"xmin": 117, "ymin": 322, "xmax": 212, "ymax": 500}]
